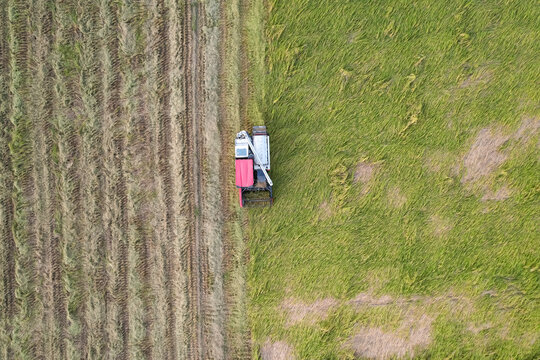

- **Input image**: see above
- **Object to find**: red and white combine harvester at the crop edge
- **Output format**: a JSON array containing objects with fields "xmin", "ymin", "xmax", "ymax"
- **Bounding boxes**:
[{"xmin": 234, "ymin": 126, "xmax": 274, "ymax": 207}]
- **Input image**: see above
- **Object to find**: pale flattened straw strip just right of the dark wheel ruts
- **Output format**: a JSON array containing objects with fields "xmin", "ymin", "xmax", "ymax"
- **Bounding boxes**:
[{"xmin": 200, "ymin": 0, "xmax": 227, "ymax": 359}]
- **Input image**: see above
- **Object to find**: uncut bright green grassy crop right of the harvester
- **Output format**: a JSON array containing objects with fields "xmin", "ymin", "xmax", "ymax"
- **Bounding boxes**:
[{"xmin": 248, "ymin": 0, "xmax": 540, "ymax": 359}]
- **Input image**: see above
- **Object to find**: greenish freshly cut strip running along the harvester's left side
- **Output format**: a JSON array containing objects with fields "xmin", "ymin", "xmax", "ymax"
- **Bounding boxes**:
[{"xmin": 221, "ymin": 0, "xmax": 251, "ymax": 360}]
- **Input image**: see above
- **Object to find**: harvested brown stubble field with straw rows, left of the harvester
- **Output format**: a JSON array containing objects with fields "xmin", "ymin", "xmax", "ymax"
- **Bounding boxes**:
[{"xmin": 0, "ymin": 0, "xmax": 245, "ymax": 359}]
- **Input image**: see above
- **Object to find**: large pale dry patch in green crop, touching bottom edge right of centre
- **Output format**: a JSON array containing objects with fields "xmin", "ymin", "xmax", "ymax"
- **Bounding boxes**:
[{"xmin": 344, "ymin": 313, "xmax": 433, "ymax": 359}]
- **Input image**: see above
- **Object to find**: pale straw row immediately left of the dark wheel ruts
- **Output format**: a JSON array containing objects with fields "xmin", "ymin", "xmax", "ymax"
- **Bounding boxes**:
[{"xmin": 156, "ymin": 0, "xmax": 190, "ymax": 359}]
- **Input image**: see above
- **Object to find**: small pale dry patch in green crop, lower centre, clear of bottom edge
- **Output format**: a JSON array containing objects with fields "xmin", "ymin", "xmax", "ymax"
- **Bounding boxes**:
[{"xmin": 281, "ymin": 298, "xmax": 338, "ymax": 326}]
